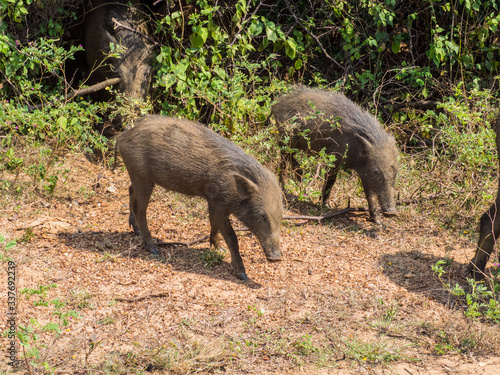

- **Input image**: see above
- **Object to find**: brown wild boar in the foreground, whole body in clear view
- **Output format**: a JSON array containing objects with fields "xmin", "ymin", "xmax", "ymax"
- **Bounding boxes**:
[{"xmin": 116, "ymin": 116, "xmax": 283, "ymax": 280}]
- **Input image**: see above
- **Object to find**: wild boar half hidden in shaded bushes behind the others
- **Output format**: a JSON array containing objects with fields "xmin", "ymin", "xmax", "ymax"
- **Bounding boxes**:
[{"xmin": 82, "ymin": 0, "xmax": 153, "ymax": 100}]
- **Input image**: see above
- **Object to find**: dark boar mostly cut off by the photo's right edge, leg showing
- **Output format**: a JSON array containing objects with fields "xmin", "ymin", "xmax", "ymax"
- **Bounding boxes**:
[{"xmin": 467, "ymin": 114, "xmax": 500, "ymax": 281}]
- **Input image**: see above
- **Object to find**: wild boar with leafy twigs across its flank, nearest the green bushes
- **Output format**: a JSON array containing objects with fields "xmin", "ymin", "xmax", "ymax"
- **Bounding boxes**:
[{"xmin": 271, "ymin": 87, "xmax": 399, "ymax": 224}]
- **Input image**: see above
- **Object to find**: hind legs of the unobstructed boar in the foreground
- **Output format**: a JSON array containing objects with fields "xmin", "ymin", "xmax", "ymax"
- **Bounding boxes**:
[{"xmin": 129, "ymin": 181, "xmax": 158, "ymax": 255}]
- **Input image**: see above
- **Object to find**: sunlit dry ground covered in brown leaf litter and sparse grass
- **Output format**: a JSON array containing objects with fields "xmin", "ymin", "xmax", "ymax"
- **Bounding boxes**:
[{"xmin": 0, "ymin": 151, "xmax": 500, "ymax": 374}]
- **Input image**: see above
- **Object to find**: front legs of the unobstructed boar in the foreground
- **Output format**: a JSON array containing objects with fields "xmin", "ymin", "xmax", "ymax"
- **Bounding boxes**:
[{"xmin": 208, "ymin": 203, "xmax": 248, "ymax": 280}]
